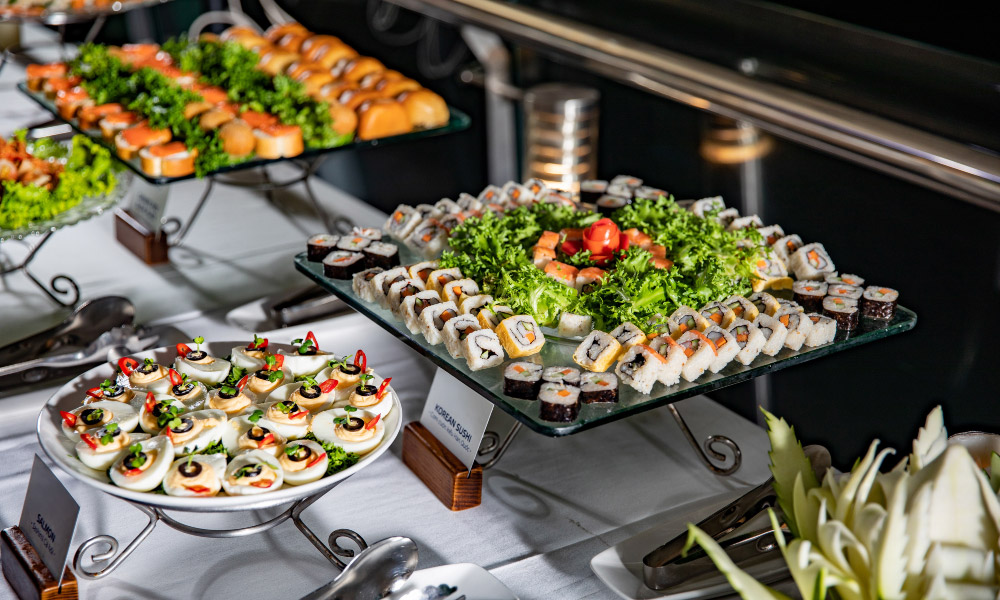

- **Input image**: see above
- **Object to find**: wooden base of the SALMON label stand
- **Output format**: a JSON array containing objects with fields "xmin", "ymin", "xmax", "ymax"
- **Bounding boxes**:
[{"xmin": 0, "ymin": 525, "xmax": 79, "ymax": 600}]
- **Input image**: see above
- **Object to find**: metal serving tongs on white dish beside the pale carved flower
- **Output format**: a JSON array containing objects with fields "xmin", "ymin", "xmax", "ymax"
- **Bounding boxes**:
[{"xmin": 642, "ymin": 446, "xmax": 830, "ymax": 590}]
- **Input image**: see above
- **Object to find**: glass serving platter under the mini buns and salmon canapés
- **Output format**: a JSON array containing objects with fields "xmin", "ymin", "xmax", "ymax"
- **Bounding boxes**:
[{"xmin": 17, "ymin": 81, "xmax": 471, "ymax": 185}]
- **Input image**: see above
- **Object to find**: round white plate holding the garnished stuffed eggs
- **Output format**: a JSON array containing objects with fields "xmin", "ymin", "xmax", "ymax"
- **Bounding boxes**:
[{"xmin": 37, "ymin": 341, "xmax": 402, "ymax": 512}]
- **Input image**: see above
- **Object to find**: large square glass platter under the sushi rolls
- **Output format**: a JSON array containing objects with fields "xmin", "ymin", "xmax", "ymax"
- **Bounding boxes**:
[{"xmin": 295, "ymin": 251, "xmax": 917, "ymax": 437}]
